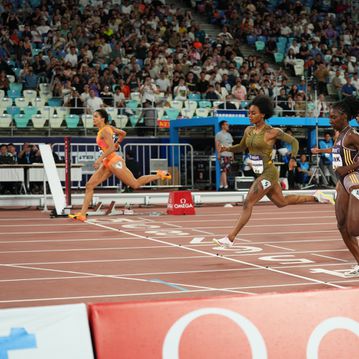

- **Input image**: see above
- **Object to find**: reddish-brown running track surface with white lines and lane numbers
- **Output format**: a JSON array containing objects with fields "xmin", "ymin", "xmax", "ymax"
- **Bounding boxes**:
[{"xmin": 0, "ymin": 204, "xmax": 359, "ymax": 308}]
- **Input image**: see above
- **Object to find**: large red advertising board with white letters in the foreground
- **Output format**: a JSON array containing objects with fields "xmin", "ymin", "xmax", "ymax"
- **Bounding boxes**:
[{"xmin": 90, "ymin": 289, "xmax": 359, "ymax": 359}]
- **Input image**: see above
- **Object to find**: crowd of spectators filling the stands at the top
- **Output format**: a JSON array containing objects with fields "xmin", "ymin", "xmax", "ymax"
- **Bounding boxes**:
[{"xmin": 0, "ymin": 0, "xmax": 359, "ymax": 121}]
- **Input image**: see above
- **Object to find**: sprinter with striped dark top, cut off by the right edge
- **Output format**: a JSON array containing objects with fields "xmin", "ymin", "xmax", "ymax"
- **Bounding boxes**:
[{"xmin": 329, "ymin": 97, "xmax": 359, "ymax": 277}]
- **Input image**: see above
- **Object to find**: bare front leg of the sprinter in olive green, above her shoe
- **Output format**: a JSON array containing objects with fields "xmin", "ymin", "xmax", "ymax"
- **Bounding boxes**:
[{"xmin": 227, "ymin": 177, "xmax": 271, "ymax": 242}]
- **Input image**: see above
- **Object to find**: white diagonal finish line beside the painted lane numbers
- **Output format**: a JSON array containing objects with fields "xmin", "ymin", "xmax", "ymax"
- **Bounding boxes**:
[{"xmin": 86, "ymin": 223, "xmax": 344, "ymax": 288}]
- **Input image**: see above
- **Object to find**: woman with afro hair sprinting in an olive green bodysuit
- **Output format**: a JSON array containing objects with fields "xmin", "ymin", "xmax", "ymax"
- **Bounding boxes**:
[{"xmin": 213, "ymin": 95, "xmax": 334, "ymax": 247}]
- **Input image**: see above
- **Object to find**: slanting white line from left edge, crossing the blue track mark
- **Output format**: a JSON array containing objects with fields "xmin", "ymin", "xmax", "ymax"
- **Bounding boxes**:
[{"xmin": 0, "ymin": 264, "xmax": 254, "ymax": 294}]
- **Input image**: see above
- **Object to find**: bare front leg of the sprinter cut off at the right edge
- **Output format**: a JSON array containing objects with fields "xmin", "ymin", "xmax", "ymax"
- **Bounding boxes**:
[{"xmin": 335, "ymin": 182, "xmax": 359, "ymax": 263}]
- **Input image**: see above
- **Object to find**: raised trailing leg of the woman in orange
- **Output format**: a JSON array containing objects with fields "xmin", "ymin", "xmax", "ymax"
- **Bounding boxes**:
[{"xmin": 110, "ymin": 160, "xmax": 166, "ymax": 189}]
